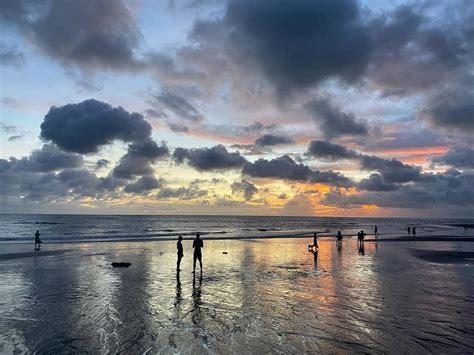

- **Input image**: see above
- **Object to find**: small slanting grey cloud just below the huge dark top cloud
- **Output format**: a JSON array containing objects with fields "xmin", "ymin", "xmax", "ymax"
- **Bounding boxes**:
[{"xmin": 304, "ymin": 97, "xmax": 369, "ymax": 138}]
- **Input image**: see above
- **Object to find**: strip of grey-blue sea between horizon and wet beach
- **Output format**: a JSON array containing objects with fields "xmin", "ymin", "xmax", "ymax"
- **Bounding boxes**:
[{"xmin": 0, "ymin": 214, "xmax": 474, "ymax": 242}]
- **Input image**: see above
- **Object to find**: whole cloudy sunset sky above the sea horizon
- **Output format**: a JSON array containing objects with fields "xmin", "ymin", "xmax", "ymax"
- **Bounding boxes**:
[{"xmin": 0, "ymin": 0, "xmax": 474, "ymax": 218}]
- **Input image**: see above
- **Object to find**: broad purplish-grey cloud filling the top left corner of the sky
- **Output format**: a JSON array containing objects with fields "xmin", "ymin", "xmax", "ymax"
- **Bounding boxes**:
[{"xmin": 0, "ymin": 0, "xmax": 141, "ymax": 70}]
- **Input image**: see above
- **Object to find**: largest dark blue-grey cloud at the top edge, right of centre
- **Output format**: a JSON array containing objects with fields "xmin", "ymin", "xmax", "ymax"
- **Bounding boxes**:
[{"xmin": 220, "ymin": 0, "xmax": 371, "ymax": 91}]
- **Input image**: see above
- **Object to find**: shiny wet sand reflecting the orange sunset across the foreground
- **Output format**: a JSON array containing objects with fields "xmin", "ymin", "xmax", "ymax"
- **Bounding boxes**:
[{"xmin": 0, "ymin": 238, "xmax": 474, "ymax": 353}]
